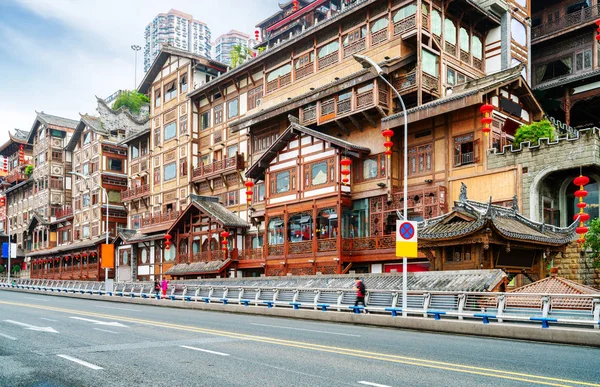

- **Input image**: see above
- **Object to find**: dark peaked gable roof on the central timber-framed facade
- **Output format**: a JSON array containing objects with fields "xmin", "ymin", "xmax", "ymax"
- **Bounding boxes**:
[{"xmin": 246, "ymin": 122, "xmax": 371, "ymax": 179}]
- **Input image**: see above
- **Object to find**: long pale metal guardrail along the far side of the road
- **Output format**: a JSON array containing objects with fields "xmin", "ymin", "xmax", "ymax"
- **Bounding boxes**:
[{"xmin": 0, "ymin": 278, "xmax": 600, "ymax": 329}]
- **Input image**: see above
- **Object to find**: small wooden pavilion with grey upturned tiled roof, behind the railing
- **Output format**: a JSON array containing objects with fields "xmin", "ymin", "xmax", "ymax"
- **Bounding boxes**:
[{"xmin": 419, "ymin": 191, "xmax": 578, "ymax": 282}]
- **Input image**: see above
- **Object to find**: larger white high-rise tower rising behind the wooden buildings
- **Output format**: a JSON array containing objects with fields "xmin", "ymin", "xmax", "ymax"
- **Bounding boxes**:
[{"xmin": 144, "ymin": 9, "xmax": 212, "ymax": 72}]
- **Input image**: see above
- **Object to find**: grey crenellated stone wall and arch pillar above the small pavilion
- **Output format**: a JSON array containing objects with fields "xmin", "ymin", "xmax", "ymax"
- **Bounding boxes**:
[{"xmin": 487, "ymin": 128, "xmax": 600, "ymax": 221}]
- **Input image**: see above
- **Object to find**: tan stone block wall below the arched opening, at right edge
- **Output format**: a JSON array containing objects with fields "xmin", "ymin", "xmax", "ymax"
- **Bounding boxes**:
[{"xmin": 554, "ymin": 242, "xmax": 600, "ymax": 289}]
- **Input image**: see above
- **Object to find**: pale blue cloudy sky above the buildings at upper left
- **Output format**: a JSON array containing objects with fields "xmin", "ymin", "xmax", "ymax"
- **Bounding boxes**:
[{"xmin": 0, "ymin": 0, "xmax": 279, "ymax": 144}]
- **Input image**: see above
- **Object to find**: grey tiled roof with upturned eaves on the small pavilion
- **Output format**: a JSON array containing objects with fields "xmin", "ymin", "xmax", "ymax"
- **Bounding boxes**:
[{"xmin": 419, "ymin": 200, "xmax": 577, "ymax": 245}]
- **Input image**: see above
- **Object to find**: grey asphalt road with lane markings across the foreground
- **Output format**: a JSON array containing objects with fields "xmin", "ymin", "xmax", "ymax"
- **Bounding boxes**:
[{"xmin": 0, "ymin": 291, "xmax": 600, "ymax": 387}]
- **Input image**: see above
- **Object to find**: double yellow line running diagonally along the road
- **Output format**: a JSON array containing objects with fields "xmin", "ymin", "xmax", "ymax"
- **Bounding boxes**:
[{"xmin": 0, "ymin": 301, "xmax": 600, "ymax": 387}]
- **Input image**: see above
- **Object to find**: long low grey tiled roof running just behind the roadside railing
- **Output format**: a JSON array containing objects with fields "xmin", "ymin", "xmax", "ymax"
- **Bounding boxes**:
[{"xmin": 168, "ymin": 269, "xmax": 506, "ymax": 292}]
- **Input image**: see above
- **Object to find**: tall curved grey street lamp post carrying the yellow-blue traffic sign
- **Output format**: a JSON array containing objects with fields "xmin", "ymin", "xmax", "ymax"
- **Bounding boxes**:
[{"xmin": 352, "ymin": 54, "xmax": 408, "ymax": 317}]
